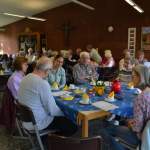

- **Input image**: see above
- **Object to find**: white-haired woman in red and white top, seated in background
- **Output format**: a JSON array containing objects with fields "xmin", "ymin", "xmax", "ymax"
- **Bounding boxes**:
[{"xmin": 101, "ymin": 50, "xmax": 115, "ymax": 67}]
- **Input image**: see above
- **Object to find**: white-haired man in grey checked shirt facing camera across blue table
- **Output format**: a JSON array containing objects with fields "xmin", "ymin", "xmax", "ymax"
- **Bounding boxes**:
[{"xmin": 73, "ymin": 52, "xmax": 98, "ymax": 84}]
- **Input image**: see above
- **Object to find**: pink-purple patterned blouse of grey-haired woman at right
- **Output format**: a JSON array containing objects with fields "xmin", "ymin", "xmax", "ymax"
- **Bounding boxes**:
[{"xmin": 132, "ymin": 87, "xmax": 150, "ymax": 133}]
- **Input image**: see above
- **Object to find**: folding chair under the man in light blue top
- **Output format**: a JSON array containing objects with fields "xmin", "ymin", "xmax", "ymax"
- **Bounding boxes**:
[{"xmin": 16, "ymin": 101, "xmax": 56, "ymax": 150}]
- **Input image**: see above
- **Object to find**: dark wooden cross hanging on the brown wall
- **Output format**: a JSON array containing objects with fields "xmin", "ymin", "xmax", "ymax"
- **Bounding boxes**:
[{"xmin": 61, "ymin": 21, "xmax": 75, "ymax": 47}]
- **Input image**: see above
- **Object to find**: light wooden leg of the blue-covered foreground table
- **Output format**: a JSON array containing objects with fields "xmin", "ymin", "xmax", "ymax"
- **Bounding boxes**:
[{"xmin": 82, "ymin": 118, "xmax": 89, "ymax": 137}]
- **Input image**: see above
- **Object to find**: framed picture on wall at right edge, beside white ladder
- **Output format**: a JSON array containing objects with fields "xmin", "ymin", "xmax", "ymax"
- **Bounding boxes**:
[{"xmin": 141, "ymin": 27, "xmax": 150, "ymax": 51}]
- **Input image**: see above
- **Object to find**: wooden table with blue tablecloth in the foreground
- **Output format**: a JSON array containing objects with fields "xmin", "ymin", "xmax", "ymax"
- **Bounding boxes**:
[{"xmin": 55, "ymin": 84, "xmax": 137, "ymax": 137}]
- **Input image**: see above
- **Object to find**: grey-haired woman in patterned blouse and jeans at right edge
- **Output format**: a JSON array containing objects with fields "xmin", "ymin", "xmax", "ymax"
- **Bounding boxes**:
[{"xmin": 100, "ymin": 65, "xmax": 150, "ymax": 150}]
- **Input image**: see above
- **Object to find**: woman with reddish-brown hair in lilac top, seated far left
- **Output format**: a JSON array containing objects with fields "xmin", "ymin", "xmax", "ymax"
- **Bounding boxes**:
[{"xmin": 7, "ymin": 56, "xmax": 28, "ymax": 99}]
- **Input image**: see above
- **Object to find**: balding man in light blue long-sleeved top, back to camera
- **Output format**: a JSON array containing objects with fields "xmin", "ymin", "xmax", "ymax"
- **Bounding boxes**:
[{"xmin": 18, "ymin": 56, "xmax": 76, "ymax": 136}]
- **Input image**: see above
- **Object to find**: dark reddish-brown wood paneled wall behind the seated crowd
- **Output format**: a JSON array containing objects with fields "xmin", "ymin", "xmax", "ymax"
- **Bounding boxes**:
[{"xmin": 0, "ymin": 0, "xmax": 150, "ymax": 59}]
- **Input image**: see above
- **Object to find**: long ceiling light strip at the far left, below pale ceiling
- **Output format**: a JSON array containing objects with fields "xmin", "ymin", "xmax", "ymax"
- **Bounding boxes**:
[{"xmin": 1, "ymin": 13, "xmax": 46, "ymax": 21}]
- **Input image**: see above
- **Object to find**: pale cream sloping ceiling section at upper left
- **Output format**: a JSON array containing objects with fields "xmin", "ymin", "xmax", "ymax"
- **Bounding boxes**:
[{"xmin": 0, "ymin": 0, "xmax": 70, "ymax": 27}]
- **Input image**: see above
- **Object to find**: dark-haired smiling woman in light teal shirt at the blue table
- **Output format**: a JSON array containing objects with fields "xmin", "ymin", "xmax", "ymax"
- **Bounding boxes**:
[{"xmin": 47, "ymin": 55, "xmax": 66, "ymax": 88}]
